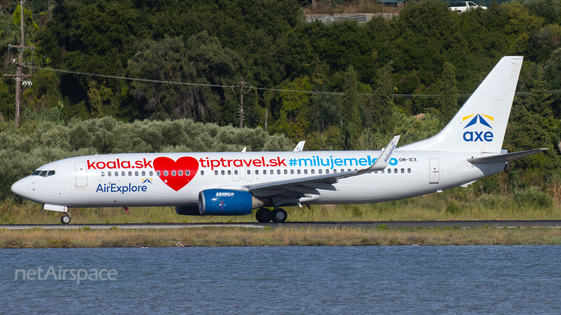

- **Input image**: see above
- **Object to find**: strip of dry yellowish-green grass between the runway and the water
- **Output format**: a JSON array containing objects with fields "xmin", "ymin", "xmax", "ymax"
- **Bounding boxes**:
[{"xmin": 0, "ymin": 227, "xmax": 561, "ymax": 248}]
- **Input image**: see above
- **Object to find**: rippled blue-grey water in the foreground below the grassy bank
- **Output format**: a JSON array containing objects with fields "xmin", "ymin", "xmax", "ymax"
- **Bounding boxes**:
[{"xmin": 0, "ymin": 246, "xmax": 561, "ymax": 314}]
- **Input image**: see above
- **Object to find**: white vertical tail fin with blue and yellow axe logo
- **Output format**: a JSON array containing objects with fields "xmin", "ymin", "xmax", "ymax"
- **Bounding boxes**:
[{"xmin": 400, "ymin": 56, "xmax": 523, "ymax": 153}]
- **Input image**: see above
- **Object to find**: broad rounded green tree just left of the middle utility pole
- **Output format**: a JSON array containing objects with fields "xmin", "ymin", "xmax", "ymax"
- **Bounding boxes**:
[{"xmin": 127, "ymin": 31, "xmax": 243, "ymax": 122}]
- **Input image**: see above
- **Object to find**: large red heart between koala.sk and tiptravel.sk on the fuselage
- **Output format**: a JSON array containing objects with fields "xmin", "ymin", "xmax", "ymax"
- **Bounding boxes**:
[{"xmin": 154, "ymin": 156, "xmax": 199, "ymax": 191}]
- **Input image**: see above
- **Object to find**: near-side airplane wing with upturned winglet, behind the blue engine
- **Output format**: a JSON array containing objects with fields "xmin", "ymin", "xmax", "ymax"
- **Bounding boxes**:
[{"xmin": 246, "ymin": 136, "xmax": 400, "ymax": 197}]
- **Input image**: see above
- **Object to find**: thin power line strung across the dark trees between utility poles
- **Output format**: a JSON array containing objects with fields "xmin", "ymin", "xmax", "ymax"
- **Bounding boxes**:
[{"xmin": 24, "ymin": 65, "xmax": 561, "ymax": 98}]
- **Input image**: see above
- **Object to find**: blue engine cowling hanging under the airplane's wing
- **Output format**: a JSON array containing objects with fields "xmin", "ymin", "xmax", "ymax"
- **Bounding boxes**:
[{"xmin": 199, "ymin": 189, "xmax": 263, "ymax": 215}]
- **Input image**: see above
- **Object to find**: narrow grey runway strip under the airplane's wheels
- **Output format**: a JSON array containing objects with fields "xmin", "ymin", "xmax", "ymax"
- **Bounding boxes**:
[{"xmin": 0, "ymin": 220, "xmax": 561, "ymax": 230}]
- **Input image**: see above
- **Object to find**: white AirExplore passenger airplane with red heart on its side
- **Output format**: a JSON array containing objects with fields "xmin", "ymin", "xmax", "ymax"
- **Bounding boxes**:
[{"xmin": 12, "ymin": 57, "xmax": 545, "ymax": 224}]
